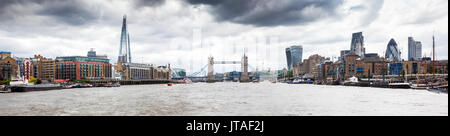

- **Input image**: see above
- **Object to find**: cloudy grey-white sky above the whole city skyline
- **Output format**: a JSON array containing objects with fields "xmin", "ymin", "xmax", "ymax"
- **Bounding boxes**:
[{"xmin": 0, "ymin": 0, "xmax": 448, "ymax": 73}]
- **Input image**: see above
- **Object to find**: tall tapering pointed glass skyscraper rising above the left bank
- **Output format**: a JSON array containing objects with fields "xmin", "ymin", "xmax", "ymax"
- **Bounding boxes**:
[{"xmin": 117, "ymin": 15, "xmax": 131, "ymax": 63}]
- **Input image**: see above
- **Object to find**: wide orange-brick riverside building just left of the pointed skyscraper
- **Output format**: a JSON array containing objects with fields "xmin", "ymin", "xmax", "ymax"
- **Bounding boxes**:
[{"xmin": 55, "ymin": 56, "xmax": 112, "ymax": 80}]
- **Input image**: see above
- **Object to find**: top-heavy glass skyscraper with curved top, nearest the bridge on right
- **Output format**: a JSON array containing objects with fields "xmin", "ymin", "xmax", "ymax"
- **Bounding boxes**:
[{"xmin": 286, "ymin": 45, "xmax": 303, "ymax": 70}]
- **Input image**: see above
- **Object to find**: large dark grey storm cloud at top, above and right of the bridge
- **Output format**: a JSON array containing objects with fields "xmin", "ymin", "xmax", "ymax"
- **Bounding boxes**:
[{"xmin": 186, "ymin": 0, "xmax": 343, "ymax": 26}]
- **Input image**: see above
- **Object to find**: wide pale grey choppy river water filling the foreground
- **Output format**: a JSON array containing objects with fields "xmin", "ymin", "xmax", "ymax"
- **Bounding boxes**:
[{"xmin": 0, "ymin": 83, "xmax": 448, "ymax": 116}]
